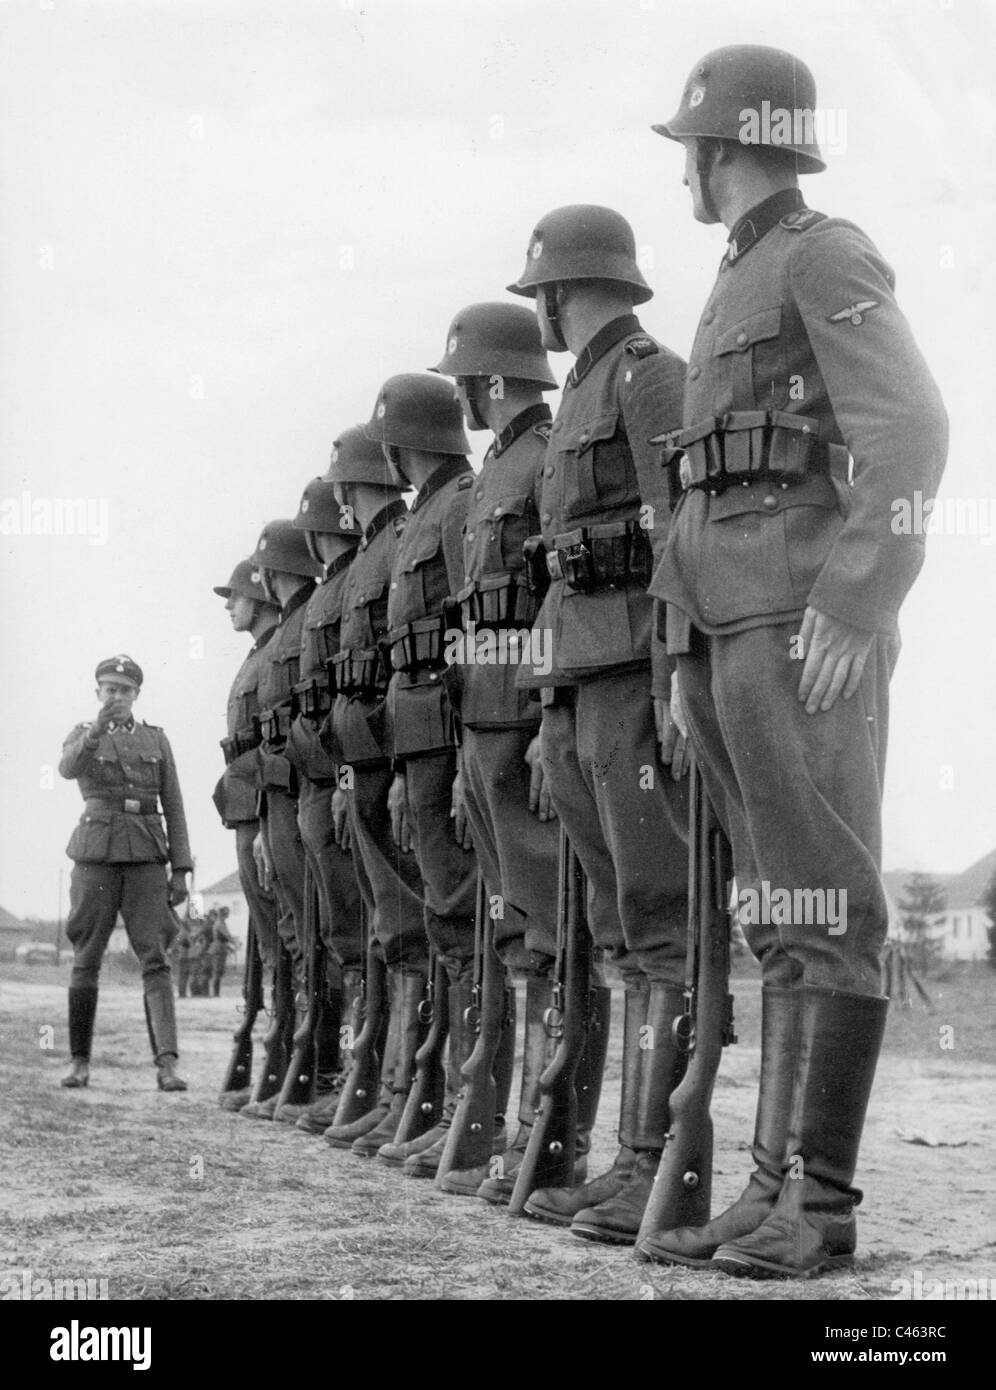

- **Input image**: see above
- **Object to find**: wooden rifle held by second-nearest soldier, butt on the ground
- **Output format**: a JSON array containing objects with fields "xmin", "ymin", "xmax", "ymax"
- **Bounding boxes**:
[{"xmin": 508, "ymin": 824, "xmax": 592, "ymax": 1216}]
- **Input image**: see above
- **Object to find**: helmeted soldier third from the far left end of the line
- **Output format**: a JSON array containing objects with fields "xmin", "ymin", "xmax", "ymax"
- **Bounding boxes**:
[{"xmin": 274, "ymin": 478, "xmax": 361, "ymax": 1126}]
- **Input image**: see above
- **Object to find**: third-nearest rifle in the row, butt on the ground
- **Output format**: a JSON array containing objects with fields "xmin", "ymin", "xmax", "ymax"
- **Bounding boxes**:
[{"xmin": 435, "ymin": 874, "xmax": 508, "ymax": 1187}]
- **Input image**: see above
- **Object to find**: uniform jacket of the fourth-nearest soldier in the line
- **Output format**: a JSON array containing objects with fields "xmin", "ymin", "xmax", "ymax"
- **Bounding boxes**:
[{"xmin": 388, "ymin": 456, "xmax": 474, "ymax": 760}]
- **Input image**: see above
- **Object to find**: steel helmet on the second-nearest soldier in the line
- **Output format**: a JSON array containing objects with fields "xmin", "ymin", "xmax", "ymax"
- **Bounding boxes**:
[{"xmin": 508, "ymin": 203, "xmax": 653, "ymax": 304}]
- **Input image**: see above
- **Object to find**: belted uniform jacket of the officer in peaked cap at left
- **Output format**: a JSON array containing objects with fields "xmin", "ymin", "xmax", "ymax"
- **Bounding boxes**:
[{"xmin": 58, "ymin": 720, "xmax": 193, "ymax": 873}]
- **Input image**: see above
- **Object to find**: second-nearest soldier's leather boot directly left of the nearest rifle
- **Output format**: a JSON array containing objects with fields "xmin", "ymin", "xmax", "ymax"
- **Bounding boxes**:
[{"xmin": 571, "ymin": 980, "xmax": 686, "ymax": 1245}]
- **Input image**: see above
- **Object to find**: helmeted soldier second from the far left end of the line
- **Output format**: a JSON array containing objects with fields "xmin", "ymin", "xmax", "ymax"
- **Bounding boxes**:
[{"xmin": 239, "ymin": 520, "xmax": 321, "ymax": 1120}]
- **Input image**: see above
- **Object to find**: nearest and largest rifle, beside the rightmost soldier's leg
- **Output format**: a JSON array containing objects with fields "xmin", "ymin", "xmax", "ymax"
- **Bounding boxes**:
[{"xmin": 638, "ymin": 762, "xmax": 736, "ymax": 1241}]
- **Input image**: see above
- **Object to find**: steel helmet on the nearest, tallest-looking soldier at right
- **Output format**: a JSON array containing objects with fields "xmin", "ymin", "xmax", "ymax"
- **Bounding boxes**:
[{"xmin": 653, "ymin": 43, "xmax": 827, "ymax": 174}]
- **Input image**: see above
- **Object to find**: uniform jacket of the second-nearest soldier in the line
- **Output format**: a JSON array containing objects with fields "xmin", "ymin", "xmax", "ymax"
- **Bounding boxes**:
[{"xmin": 520, "ymin": 314, "xmax": 685, "ymax": 688}]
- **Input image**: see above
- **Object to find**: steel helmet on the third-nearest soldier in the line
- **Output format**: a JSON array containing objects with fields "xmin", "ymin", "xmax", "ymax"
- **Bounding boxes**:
[{"xmin": 433, "ymin": 304, "xmax": 557, "ymax": 391}]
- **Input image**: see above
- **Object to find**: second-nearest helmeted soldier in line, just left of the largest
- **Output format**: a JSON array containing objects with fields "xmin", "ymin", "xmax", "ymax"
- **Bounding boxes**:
[{"xmin": 510, "ymin": 204, "xmax": 688, "ymax": 1243}]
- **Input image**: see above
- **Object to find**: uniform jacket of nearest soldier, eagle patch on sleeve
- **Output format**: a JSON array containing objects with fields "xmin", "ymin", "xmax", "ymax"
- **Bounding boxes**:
[{"xmin": 651, "ymin": 189, "xmax": 947, "ymax": 652}]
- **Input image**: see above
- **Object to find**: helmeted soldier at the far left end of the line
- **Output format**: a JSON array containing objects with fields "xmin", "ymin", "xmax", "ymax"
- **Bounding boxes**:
[{"xmin": 214, "ymin": 560, "xmax": 279, "ymax": 1111}]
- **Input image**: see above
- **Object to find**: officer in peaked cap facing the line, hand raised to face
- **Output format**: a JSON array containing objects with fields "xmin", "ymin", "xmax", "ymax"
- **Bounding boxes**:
[{"xmin": 58, "ymin": 655, "xmax": 193, "ymax": 1091}]
